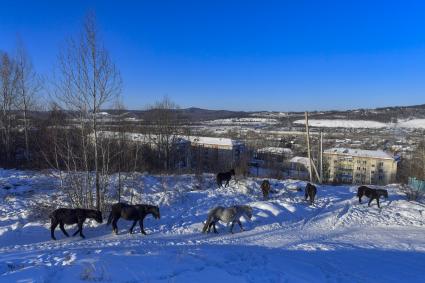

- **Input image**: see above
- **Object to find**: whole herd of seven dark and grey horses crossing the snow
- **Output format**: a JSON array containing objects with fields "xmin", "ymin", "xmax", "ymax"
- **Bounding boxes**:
[{"xmin": 49, "ymin": 169, "xmax": 388, "ymax": 240}]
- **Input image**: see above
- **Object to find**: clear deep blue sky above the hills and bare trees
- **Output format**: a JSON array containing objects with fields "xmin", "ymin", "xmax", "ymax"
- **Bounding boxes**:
[{"xmin": 0, "ymin": 0, "xmax": 425, "ymax": 111}]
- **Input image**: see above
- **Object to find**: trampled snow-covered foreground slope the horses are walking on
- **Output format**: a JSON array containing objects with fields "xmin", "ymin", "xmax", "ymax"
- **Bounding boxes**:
[{"xmin": 0, "ymin": 169, "xmax": 425, "ymax": 282}]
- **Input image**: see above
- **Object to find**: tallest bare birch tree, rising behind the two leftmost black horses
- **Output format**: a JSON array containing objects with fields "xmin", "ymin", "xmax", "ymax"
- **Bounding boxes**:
[{"xmin": 57, "ymin": 14, "xmax": 122, "ymax": 209}]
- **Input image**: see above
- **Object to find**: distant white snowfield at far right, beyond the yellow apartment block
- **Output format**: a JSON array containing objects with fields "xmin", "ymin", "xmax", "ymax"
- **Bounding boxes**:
[{"xmin": 294, "ymin": 119, "xmax": 425, "ymax": 129}]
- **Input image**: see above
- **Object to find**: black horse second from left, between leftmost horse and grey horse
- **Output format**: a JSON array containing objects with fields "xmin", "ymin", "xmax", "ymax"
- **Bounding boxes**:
[{"xmin": 107, "ymin": 203, "xmax": 161, "ymax": 235}]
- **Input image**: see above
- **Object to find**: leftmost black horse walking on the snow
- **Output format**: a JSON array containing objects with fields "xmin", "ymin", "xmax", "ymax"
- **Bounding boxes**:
[{"xmin": 49, "ymin": 208, "xmax": 102, "ymax": 240}]
